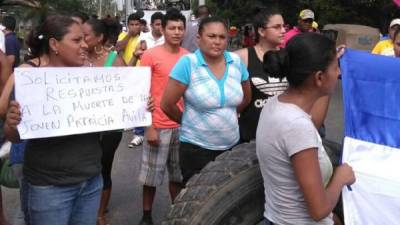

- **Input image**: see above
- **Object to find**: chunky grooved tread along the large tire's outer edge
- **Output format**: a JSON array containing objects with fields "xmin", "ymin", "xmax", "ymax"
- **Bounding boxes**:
[{"xmin": 162, "ymin": 142, "xmax": 258, "ymax": 225}]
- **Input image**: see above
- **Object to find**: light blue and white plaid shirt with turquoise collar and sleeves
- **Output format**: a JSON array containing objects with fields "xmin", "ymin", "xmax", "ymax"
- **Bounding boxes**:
[{"xmin": 170, "ymin": 50, "xmax": 249, "ymax": 150}]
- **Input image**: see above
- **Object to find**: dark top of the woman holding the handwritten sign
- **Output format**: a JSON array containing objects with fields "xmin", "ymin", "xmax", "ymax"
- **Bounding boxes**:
[{"xmin": 19, "ymin": 61, "xmax": 102, "ymax": 186}]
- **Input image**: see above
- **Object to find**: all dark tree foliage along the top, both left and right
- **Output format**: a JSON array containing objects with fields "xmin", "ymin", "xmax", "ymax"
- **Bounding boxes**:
[{"xmin": 0, "ymin": 0, "xmax": 400, "ymax": 32}]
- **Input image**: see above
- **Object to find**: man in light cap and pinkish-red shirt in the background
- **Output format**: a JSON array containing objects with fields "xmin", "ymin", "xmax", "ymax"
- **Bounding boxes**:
[{"xmin": 280, "ymin": 9, "xmax": 315, "ymax": 48}]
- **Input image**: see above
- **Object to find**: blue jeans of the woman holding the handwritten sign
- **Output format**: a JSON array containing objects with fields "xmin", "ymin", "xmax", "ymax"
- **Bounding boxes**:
[{"xmin": 22, "ymin": 174, "xmax": 103, "ymax": 225}]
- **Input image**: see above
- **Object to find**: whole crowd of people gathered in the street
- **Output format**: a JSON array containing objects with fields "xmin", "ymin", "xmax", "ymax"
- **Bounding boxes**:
[{"xmin": 0, "ymin": 6, "xmax": 400, "ymax": 225}]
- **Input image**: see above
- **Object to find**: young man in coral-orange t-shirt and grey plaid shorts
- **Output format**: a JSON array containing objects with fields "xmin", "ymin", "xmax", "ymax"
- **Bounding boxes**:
[{"xmin": 139, "ymin": 10, "xmax": 188, "ymax": 225}]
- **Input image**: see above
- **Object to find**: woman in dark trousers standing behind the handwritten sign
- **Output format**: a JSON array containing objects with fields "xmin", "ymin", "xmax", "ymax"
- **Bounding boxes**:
[{"xmin": 82, "ymin": 18, "xmax": 125, "ymax": 225}]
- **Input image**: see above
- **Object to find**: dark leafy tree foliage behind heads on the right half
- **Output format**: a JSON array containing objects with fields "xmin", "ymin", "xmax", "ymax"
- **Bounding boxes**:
[{"xmin": 206, "ymin": 0, "xmax": 400, "ymax": 32}]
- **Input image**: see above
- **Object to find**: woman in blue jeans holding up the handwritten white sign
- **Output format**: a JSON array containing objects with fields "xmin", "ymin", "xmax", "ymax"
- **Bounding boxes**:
[{"xmin": 4, "ymin": 16, "xmax": 102, "ymax": 225}]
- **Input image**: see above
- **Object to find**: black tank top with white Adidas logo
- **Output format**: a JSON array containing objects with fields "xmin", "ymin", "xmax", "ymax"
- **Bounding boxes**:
[{"xmin": 239, "ymin": 47, "xmax": 288, "ymax": 141}]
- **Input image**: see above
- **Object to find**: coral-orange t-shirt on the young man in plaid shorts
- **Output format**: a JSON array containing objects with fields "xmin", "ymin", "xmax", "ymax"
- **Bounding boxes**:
[{"xmin": 140, "ymin": 45, "xmax": 188, "ymax": 128}]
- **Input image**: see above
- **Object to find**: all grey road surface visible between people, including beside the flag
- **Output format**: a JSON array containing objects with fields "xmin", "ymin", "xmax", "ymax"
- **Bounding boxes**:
[{"xmin": 3, "ymin": 83, "xmax": 343, "ymax": 225}]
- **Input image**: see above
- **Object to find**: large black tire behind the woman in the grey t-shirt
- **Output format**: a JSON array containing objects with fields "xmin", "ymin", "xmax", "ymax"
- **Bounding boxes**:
[{"xmin": 162, "ymin": 141, "xmax": 340, "ymax": 225}]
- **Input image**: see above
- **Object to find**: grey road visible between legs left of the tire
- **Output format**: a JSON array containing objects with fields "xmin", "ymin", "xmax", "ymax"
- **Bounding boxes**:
[{"xmin": 2, "ymin": 132, "xmax": 170, "ymax": 225}]
